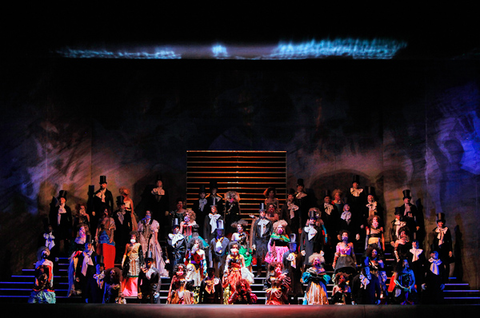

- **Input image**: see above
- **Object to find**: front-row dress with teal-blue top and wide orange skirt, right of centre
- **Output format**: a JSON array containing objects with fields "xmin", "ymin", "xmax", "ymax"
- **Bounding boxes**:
[{"xmin": 302, "ymin": 266, "xmax": 330, "ymax": 305}]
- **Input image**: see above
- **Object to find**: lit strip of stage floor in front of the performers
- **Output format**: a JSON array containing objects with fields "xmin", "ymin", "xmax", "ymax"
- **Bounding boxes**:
[{"xmin": 4, "ymin": 304, "xmax": 480, "ymax": 318}]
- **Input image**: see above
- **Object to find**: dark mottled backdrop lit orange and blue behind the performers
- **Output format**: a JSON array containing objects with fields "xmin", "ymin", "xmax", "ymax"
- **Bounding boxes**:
[{"xmin": 0, "ymin": 59, "xmax": 480, "ymax": 288}]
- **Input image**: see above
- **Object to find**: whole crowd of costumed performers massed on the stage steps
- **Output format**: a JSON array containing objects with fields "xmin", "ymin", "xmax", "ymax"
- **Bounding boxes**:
[{"xmin": 29, "ymin": 176, "xmax": 453, "ymax": 305}]
